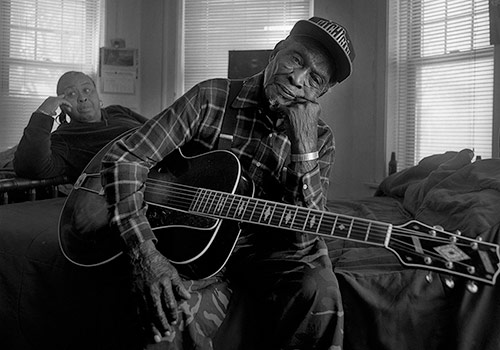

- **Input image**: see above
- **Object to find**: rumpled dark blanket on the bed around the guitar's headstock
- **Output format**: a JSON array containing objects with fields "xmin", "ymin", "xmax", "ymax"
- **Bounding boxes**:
[{"xmin": 330, "ymin": 150, "xmax": 500, "ymax": 350}]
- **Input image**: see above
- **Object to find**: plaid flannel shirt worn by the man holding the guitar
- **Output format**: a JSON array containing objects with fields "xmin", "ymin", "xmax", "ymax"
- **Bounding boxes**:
[{"xmin": 101, "ymin": 73, "xmax": 335, "ymax": 248}]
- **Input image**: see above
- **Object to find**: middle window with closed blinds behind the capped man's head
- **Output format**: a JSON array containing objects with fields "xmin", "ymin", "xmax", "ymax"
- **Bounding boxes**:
[{"xmin": 184, "ymin": 0, "xmax": 312, "ymax": 90}]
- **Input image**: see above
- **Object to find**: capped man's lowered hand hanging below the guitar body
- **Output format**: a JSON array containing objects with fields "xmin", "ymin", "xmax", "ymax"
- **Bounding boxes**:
[{"xmin": 129, "ymin": 241, "xmax": 191, "ymax": 343}]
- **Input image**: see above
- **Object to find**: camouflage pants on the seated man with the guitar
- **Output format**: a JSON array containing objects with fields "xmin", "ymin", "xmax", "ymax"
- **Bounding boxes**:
[{"xmin": 148, "ymin": 237, "xmax": 344, "ymax": 350}]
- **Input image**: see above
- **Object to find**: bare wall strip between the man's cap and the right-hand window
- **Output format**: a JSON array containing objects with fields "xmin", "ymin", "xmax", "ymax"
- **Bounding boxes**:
[{"xmin": 315, "ymin": 0, "xmax": 389, "ymax": 198}]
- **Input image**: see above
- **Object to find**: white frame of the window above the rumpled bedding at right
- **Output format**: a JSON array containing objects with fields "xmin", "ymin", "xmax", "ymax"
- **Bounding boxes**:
[{"xmin": 386, "ymin": 0, "xmax": 499, "ymax": 169}]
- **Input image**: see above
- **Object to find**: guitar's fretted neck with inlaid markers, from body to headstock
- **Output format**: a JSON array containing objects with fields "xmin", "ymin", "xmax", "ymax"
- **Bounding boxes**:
[{"xmin": 188, "ymin": 189, "xmax": 392, "ymax": 247}]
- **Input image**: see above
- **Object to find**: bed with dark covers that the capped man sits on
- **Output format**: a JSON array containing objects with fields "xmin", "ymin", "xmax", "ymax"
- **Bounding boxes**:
[{"xmin": 0, "ymin": 150, "xmax": 500, "ymax": 350}]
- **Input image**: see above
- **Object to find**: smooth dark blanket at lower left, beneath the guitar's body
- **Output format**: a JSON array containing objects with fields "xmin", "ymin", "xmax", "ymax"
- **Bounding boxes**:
[{"xmin": 0, "ymin": 198, "xmax": 146, "ymax": 350}]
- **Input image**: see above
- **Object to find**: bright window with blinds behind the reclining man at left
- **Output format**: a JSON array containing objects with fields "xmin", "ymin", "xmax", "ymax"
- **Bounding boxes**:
[{"xmin": 0, "ymin": 0, "xmax": 101, "ymax": 151}]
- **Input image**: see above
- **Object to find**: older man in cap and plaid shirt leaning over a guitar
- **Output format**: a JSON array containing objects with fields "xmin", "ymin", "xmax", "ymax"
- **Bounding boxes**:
[{"xmin": 102, "ymin": 17, "xmax": 354, "ymax": 349}]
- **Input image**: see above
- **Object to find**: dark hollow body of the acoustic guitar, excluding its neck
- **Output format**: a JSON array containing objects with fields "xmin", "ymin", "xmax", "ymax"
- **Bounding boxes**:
[{"xmin": 59, "ymin": 131, "xmax": 253, "ymax": 279}]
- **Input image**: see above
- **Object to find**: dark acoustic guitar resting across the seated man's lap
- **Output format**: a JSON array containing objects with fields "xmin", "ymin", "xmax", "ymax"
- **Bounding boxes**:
[{"xmin": 59, "ymin": 134, "xmax": 499, "ymax": 291}]
